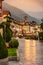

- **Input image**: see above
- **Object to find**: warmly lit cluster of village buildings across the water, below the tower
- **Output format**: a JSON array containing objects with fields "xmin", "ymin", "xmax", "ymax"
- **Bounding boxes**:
[{"xmin": 11, "ymin": 20, "xmax": 40, "ymax": 35}]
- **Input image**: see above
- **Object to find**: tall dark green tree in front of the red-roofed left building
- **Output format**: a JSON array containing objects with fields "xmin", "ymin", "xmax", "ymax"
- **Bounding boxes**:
[{"xmin": 0, "ymin": 16, "xmax": 13, "ymax": 42}]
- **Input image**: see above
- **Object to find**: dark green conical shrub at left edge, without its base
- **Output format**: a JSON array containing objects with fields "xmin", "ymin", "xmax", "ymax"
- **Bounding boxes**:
[{"xmin": 0, "ymin": 34, "xmax": 8, "ymax": 59}]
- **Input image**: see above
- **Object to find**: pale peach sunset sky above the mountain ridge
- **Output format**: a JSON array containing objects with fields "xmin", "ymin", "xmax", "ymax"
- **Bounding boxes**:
[{"xmin": 4, "ymin": 0, "xmax": 43, "ymax": 17}]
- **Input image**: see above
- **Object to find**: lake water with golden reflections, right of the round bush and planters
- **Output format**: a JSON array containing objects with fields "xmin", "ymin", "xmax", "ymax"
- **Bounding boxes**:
[{"xmin": 9, "ymin": 39, "xmax": 43, "ymax": 65}]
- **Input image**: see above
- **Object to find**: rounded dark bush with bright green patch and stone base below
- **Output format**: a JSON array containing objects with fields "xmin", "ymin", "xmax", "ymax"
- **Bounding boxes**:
[{"xmin": 8, "ymin": 39, "xmax": 19, "ymax": 61}]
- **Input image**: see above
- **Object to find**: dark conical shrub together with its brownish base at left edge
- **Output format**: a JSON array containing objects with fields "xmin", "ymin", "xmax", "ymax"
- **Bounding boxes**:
[{"xmin": 0, "ymin": 34, "xmax": 8, "ymax": 65}]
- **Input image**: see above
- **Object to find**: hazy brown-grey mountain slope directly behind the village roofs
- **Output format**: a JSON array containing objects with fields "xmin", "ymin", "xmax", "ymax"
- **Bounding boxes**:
[{"xmin": 3, "ymin": 2, "xmax": 40, "ymax": 23}]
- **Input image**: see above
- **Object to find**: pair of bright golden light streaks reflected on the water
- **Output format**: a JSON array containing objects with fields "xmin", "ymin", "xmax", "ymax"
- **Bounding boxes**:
[{"xmin": 25, "ymin": 40, "xmax": 36, "ymax": 62}]
